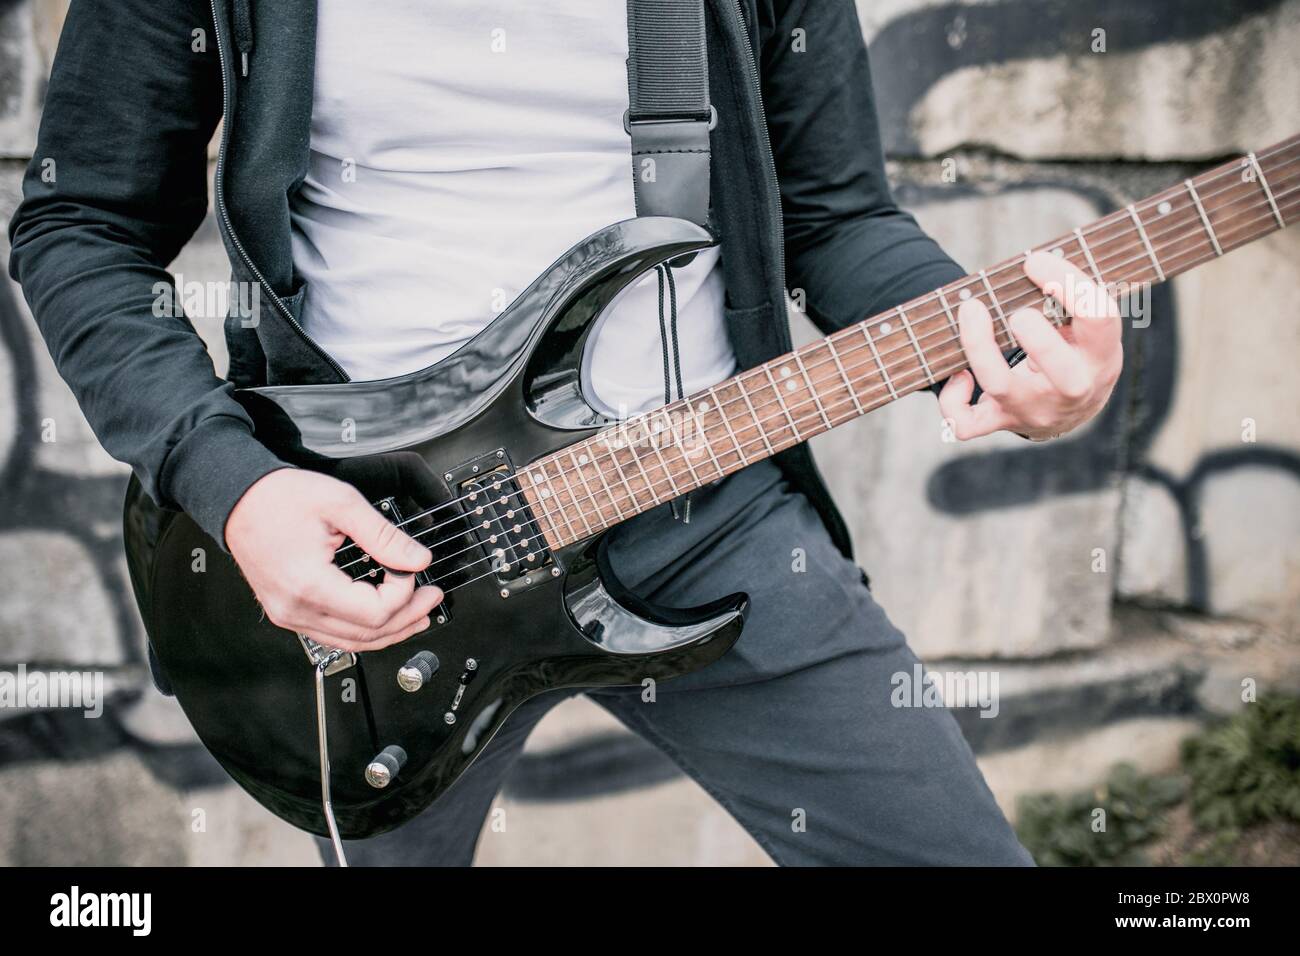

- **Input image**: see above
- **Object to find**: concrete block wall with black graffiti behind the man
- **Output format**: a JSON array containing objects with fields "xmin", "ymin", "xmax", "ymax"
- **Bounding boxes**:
[{"xmin": 0, "ymin": 0, "xmax": 1300, "ymax": 864}]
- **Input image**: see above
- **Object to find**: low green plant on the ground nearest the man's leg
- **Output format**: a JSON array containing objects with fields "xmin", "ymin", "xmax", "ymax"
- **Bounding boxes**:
[{"xmin": 1018, "ymin": 763, "xmax": 1184, "ymax": 866}]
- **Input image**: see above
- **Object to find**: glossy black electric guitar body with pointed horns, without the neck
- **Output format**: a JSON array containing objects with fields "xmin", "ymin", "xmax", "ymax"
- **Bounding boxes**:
[{"xmin": 125, "ymin": 217, "xmax": 746, "ymax": 838}]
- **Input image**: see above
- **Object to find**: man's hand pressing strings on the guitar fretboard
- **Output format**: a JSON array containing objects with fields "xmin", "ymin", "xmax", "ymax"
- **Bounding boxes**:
[{"xmin": 939, "ymin": 252, "xmax": 1123, "ymax": 441}]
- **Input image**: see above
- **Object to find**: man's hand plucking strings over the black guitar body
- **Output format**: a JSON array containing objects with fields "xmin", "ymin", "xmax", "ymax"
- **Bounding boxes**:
[{"xmin": 226, "ymin": 468, "xmax": 442, "ymax": 650}]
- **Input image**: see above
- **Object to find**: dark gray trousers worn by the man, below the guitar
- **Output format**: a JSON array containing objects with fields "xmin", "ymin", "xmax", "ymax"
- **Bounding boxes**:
[{"xmin": 319, "ymin": 462, "xmax": 1032, "ymax": 866}]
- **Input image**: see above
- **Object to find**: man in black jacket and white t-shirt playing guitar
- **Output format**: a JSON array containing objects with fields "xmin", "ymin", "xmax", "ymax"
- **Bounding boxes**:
[{"xmin": 10, "ymin": 0, "xmax": 1121, "ymax": 865}]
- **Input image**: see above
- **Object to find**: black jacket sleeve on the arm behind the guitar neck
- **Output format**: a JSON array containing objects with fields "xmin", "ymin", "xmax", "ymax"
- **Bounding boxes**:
[{"xmin": 762, "ymin": 0, "xmax": 965, "ymax": 351}]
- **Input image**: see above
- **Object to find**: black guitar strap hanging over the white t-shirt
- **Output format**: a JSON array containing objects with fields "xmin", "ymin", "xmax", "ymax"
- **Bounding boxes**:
[{"xmin": 623, "ymin": 0, "xmax": 718, "ymax": 225}]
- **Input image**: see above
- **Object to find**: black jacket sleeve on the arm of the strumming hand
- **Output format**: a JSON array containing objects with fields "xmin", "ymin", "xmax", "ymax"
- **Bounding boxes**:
[{"xmin": 9, "ymin": 0, "xmax": 282, "ymax": 546}]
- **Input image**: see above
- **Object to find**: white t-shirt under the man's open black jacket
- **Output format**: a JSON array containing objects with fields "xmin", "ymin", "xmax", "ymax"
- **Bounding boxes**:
[{"xmin": 291, "ymin": 0, "xmax": 736, "ymax": 415}]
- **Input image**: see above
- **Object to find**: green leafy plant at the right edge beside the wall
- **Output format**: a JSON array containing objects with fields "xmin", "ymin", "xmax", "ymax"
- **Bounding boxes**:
[{"xmin": 1183, "ymin": 697, "xmax": 1300, "ymax": 830}]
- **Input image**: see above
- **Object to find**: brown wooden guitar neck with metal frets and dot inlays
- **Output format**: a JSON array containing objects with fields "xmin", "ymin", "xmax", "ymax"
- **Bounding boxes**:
[{"xmin": 521, "ymin": 135, "xmax": 1300, "ymax": 549}]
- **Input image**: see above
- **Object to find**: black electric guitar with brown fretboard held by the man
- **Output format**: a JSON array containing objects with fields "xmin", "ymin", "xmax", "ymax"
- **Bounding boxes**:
[{"xmin": 125, "ymin": 137, "xmax": 1300, "ymax": 842}]
